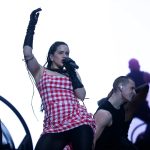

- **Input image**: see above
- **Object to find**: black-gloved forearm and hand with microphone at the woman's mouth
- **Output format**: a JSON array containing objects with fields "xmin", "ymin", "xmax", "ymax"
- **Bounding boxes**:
[{"xmin": 63, "ymin": 58, "xmax": 83, "ymax": 90}]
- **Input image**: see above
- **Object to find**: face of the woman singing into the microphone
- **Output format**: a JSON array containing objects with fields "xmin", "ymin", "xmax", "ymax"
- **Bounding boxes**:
[{"xmin": 50, "ymin": 45, "xmax": 69, "ymax": 68}]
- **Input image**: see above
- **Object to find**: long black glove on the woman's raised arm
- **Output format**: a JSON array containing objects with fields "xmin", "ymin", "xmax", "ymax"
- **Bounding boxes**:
[{"xmin": 23, "ymin": 8, "xmax": 42, "ymax": 48}]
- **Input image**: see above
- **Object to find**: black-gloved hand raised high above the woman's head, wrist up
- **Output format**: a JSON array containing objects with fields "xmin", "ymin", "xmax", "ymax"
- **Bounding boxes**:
[{"xmin": 30, "ymin": 8, "xmax": 42, "ymax": 25}]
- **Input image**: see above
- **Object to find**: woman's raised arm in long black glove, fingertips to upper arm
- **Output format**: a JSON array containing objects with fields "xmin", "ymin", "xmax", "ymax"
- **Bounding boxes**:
[{"xmin": 23, "ymin": 8, "xmax": 41, "ymax": 77}]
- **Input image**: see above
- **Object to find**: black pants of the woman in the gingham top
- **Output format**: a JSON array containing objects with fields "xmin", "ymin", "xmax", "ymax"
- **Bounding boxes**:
[{"xmin": 35, "ymin": 125, "xmax": 94, "ymax": 150}]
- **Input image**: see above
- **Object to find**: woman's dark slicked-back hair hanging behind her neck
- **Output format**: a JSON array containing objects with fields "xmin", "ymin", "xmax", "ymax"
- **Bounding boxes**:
[{"xmin": 46, "ymin": 41, "xmax": 68, "ymax": 69}]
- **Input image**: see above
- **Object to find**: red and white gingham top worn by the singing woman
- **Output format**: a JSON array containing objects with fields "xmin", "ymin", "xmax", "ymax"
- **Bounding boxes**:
[{"xmin": 37, "ymin": 69, "xmax": 95, "ymax": 133}]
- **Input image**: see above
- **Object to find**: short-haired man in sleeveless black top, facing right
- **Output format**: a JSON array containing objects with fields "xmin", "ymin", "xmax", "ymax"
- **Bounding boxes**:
[{"xmin": 94, "ymin": 76, "xmax": 136, "ymax": 150}]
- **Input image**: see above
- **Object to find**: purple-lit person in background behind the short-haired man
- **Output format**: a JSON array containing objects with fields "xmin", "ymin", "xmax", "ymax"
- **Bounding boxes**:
[{"xmin": 126, "ymin": 58, "xmax": 150, "ymax": 150}]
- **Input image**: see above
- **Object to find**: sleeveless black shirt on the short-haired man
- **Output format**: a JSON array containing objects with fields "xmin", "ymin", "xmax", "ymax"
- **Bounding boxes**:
[{"xmin": 95, "ymin": 99, "xmax": 125, "ymax": 150}]
